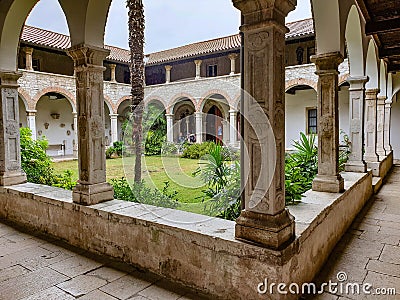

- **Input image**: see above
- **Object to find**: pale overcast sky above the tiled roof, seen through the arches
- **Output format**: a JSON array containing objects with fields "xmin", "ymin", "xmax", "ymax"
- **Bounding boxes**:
[{"xmin": 27, "ymin": 0, "xmax": 311, "ymax": 53}]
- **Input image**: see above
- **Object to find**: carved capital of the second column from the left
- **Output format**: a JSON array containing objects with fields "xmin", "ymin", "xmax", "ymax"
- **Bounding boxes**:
[{"xmin": 67, "ymin": 44, "xmax": 110, "ymax": 67}]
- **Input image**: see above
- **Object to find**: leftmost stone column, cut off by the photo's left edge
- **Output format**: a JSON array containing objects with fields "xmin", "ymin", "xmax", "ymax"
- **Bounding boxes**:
[{"xmin": 0, "ymin": 72, "xmax": 26, "ymax": 186}]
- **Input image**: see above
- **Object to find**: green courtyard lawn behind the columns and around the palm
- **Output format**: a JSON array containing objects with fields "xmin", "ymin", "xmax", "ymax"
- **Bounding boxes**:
[{"xmin": 54, "ymin": 156, "xmax": 209, "ymax": 213}]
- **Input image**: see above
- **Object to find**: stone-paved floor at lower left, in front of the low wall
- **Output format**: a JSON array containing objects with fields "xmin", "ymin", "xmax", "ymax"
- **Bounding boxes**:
[{"xmin": 0, "ymin": 223, "xmax": 206, "ymax": 300}]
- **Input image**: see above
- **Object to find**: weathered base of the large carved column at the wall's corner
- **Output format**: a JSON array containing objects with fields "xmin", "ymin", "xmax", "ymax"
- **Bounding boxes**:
[{"xmin": 235, "ymin": 209, "xmax": 295, "ymax": 250}]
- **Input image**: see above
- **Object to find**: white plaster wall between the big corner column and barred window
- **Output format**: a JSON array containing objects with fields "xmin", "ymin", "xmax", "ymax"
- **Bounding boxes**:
[{"xmin": 285, "ymin": 89, "xmax": 317, "ymax": 150}]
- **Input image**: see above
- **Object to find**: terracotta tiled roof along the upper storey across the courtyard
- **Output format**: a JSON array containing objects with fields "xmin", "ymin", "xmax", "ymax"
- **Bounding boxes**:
[{"xmin": 21, "ymin": 19, "xmax": 314, "ymax": 65}]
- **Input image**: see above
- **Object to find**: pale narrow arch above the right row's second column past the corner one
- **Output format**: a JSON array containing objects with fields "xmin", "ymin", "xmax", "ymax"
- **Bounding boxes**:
[{"xmin": 345, "ymin": 5, "xmax": 365, "ymax": 77}]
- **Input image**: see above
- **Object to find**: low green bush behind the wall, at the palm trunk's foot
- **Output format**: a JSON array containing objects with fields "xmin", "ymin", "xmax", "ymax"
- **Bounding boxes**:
[{"xmin": 111, "ymin": 178, "xmax": 179, "ymax": 208}]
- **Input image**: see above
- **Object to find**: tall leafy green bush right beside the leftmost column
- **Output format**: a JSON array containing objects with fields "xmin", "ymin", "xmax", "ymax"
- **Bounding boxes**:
[{"xmin": 20, "ymin": 128, "xmax": 55, "ymax": 185}]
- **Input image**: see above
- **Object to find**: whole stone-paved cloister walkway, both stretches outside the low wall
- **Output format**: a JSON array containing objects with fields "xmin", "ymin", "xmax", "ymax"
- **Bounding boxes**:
[{"xmin": 0, "ymin": 165, "xmax": 400, "ymax": 300}]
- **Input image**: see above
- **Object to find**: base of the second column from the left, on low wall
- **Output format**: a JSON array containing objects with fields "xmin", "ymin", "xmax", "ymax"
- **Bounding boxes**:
[{"xmin": 72, "ymin": 182, "xmax": 114, "ymax": 205}]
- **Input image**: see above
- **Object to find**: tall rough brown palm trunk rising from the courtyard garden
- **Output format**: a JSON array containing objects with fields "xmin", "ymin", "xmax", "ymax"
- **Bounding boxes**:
[{"xmin": 126, "ymin": 0, "xmax": 145, "ymax": 182}]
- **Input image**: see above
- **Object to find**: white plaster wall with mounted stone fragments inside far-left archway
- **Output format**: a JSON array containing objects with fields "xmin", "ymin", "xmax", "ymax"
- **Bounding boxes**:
[{"xmin": 36, "ymin": 96, "xmax": 74, "ymax": 156}]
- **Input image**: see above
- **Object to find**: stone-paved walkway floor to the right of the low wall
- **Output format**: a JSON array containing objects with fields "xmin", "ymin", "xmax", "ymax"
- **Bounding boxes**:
[{"xmin": 310, "ymin": 165, "xmax": 400, "ymax": 300}]
